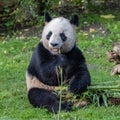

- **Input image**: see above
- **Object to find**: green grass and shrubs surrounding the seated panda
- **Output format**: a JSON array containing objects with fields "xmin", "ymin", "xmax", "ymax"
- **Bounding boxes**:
[{"xmin": 0, "ymin": 0, "xmax": 120, "ymax": 120}]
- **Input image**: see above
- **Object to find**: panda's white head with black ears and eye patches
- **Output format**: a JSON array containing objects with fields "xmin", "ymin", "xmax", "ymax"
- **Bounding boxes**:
[{"xmin": 42, "ymin": 13, "xmax": 78, "ymax": 54}]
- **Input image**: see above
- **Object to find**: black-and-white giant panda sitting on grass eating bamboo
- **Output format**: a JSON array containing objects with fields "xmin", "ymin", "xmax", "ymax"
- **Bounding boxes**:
[{"xmin": 26, "ymin": 13, "xmax": 91, "ymax": 113}]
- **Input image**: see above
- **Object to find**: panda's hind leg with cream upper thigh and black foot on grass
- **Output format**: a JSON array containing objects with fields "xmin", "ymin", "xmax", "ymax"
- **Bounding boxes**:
[{"xmin": 26, "ymin": 72, "xmax": 71, "ymax": 113}]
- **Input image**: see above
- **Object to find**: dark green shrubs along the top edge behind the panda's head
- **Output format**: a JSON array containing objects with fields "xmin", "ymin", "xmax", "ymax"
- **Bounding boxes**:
[{"xmin": 0, "ymin": 0, "xmax": 120, "ymax": 33}]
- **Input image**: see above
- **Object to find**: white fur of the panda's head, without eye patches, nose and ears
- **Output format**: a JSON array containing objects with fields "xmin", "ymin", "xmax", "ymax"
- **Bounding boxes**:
[{"xmin": 42, "ymin": 17, "xmax": 76, "ymax": 54}]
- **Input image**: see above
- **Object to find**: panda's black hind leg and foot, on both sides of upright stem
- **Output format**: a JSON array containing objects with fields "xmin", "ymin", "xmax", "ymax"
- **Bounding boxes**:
[{"xmin": 28, "ymin": 88, "xmax": 71, "ymax": 113}]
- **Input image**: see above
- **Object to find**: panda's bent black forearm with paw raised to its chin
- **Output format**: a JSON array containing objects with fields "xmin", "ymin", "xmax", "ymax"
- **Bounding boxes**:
[{"xmin": 37, "ymin": 54, "xmax": 68, "ymax": 86}]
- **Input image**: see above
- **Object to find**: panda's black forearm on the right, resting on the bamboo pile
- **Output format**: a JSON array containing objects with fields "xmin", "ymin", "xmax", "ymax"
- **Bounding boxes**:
[{"xmin": 69, "ymin": 63, "xmax": 91, "ymax": 94}]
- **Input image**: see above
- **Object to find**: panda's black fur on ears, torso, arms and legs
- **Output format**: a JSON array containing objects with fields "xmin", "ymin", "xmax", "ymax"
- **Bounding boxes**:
[{"xmin": 26, "ymin": 14, "xmax": 90, "ymax": 113}]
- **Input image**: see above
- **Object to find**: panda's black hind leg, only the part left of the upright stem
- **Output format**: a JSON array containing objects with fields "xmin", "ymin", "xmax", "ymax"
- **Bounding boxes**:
[{"xmin": 28, "ymin": 88, "xmax": 58, "ymax": 112}]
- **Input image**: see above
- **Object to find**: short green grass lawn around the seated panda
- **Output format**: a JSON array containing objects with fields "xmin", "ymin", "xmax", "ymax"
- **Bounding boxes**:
[{"xmin": 0, "ymin": 10, "xmax": 120, "ymax": 120}]
